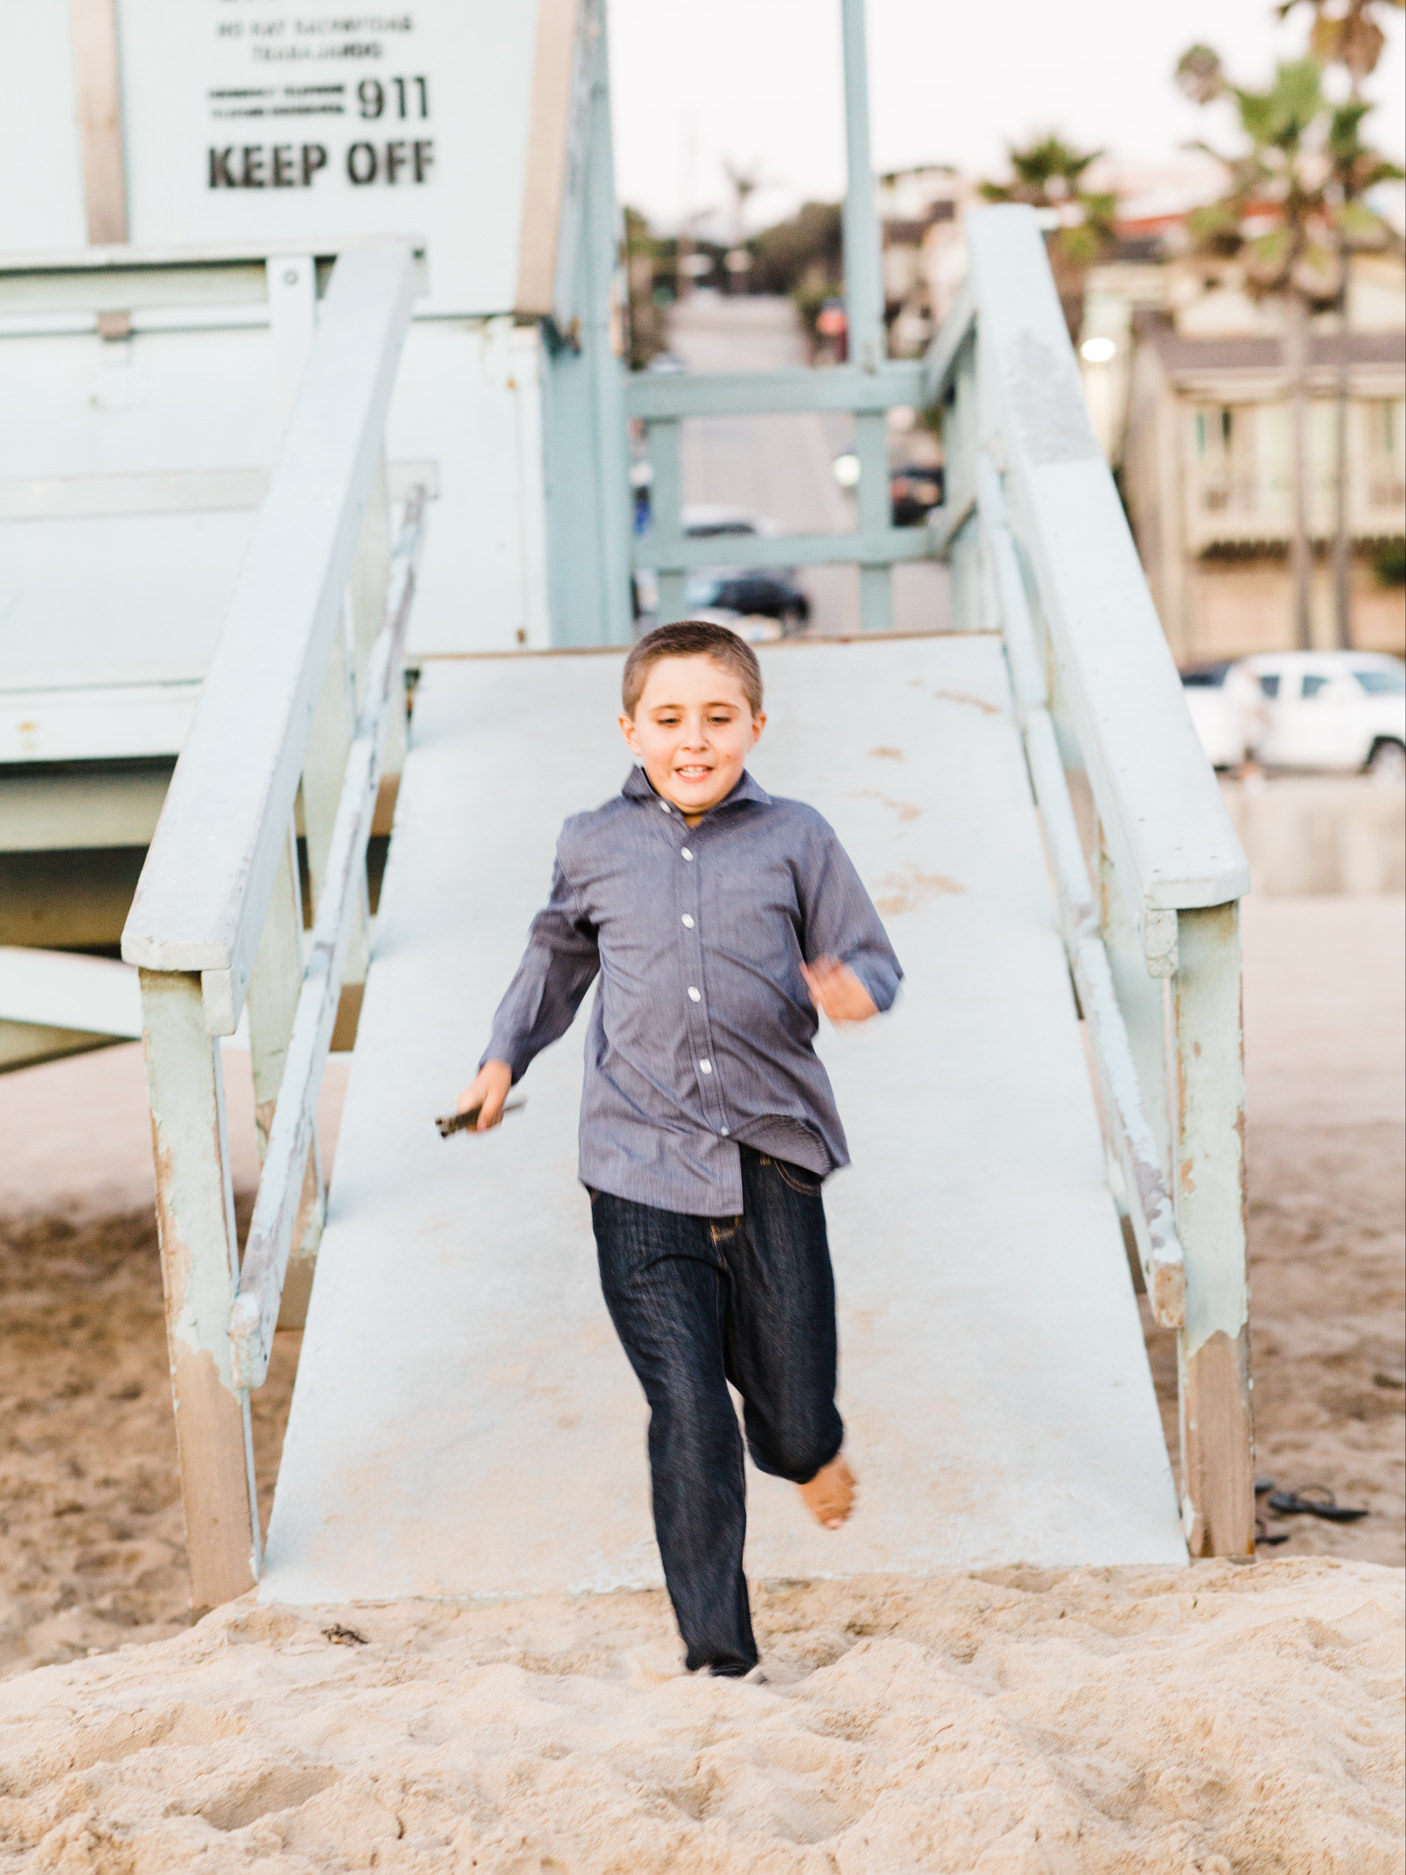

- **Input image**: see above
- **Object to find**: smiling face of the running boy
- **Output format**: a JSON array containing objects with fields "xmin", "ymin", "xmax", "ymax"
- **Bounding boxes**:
[{"xmin": 621, "ymin": 658, "xmax": 767, "ymax": 818}]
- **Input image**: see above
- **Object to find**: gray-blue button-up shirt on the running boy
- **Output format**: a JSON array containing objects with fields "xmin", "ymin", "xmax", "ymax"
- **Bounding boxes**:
[{"xmin": 484, "ymin": 769, "xmax": 904, "ymax": 1217}]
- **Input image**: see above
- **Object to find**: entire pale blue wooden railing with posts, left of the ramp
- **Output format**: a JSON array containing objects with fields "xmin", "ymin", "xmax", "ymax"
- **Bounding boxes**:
[{"xmin": 122, "ymin": 242, "xmax": 424, "ymax": 1609}]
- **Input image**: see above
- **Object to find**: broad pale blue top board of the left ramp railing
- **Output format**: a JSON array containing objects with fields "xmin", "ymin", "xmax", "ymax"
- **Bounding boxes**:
[{"xmin": 122, "ymin": 242, "xmax": 414, "ymax": 1035}]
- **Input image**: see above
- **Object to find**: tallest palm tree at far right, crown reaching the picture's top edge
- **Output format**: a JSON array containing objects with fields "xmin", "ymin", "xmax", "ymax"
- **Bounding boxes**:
[{"xmin": 1279, "ymin": 0, "xmax": 1406, "ymax": 651}]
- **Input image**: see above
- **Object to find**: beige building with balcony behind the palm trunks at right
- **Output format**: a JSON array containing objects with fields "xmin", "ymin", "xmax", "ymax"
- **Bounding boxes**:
[{"xmin": 1082, "ymin": 257, "xmax": 1406, "ymax": 664}]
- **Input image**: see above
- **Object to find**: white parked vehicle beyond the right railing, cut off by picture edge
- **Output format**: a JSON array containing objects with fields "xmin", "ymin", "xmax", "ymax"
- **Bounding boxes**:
[{"xmin": 1239, "ymin": 651, "xmax": 1406, "ymax": 780}]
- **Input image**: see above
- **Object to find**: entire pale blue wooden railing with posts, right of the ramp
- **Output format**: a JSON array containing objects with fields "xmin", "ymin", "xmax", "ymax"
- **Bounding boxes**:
[{"xmin": 948, "ymin": 206, "xmax": 1254, "ymax": 1556}]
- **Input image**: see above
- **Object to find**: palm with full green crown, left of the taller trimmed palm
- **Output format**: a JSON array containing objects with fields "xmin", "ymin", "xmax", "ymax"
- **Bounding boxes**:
[{"xmin": 1177, "ymin": 45, "xmax": 1342, "ymax": 649}]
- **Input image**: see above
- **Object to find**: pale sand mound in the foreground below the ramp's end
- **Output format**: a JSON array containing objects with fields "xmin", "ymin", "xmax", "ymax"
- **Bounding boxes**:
[{"xmin": 0, "ymin": 1560, "xmax": 1402, "ymax": 1875}]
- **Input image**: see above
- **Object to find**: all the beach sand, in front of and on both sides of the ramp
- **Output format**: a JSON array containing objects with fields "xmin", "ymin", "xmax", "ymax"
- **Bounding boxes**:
[{"xmin": 0, "ymin": 898, "xmax": 1406, "ymax": 1875}]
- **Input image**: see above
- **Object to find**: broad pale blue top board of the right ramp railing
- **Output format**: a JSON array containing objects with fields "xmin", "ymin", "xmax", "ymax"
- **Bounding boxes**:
[{"xmin": 934, "ymin": 204, "xmax": 1250, "ymax": 975}]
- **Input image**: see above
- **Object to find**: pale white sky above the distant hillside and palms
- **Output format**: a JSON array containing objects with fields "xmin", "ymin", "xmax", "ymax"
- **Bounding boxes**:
[{"xmin": 607, "ymin": 0, "xmax": 1406, "ymax": 229}]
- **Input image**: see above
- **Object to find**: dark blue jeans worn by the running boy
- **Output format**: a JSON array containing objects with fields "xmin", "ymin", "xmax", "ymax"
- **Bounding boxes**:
[{"xmin": 591, "ymin": 1146, "xmax": 844, "ymax": 1674}]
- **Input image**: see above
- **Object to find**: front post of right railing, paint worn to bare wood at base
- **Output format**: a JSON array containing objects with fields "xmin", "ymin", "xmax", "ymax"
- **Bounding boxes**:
[{"xmin": 1172, "ymin": 904, "xmax": 1254, "ymax": 1556}]
